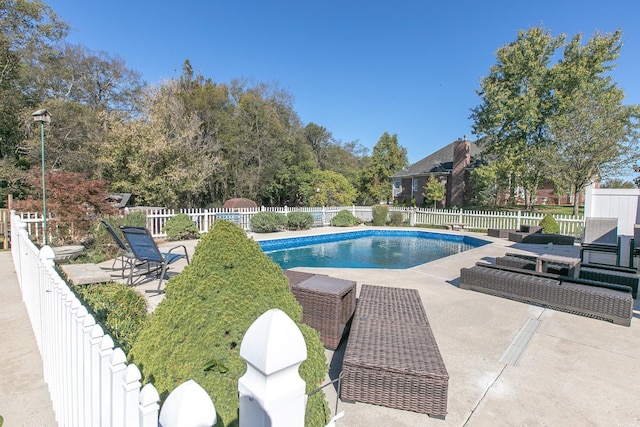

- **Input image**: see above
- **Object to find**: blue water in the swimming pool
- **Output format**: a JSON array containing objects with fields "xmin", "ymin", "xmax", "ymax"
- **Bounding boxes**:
[{"xmin": 258, "ymin": 230, "xmax": 489, "ymax": 269}]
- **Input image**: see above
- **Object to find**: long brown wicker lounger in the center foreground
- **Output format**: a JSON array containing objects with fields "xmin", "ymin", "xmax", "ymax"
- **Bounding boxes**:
[{"xmin": 340, "ymin": 285, "xmax": 449, "ymax": 418}]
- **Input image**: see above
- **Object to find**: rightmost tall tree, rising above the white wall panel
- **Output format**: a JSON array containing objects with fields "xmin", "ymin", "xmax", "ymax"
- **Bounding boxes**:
[{"xmin": 549, "ymin": 31, "xmax": 640, "ymax": 215}]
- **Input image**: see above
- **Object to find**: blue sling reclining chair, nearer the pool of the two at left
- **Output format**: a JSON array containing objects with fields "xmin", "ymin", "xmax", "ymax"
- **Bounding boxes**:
[{"xmin": 120, "ymin": 226, "xmax": 189, "ymax": 294}]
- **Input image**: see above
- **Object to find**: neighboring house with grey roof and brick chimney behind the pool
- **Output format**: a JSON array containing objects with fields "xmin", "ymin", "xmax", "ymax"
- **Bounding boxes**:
[{"xmin": 391, "ymin": 136, "xmax": 481, "ymax": 207}]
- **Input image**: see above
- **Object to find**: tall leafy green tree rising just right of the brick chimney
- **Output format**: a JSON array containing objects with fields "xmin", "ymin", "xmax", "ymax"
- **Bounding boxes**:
[{"xmin": 470, "ymin": 27, "xmax": 565, "ymax": 208}]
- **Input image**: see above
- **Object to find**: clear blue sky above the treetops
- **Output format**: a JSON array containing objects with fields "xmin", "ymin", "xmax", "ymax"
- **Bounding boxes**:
[{"xmin": 44, "ymin": 0, "xmax": 640, "ymax": 172}]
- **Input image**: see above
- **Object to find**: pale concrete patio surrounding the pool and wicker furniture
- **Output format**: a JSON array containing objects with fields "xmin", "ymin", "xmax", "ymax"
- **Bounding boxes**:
[{"xmin": 1, "ymin": 227, "xmax": 640, "ymax": 427}]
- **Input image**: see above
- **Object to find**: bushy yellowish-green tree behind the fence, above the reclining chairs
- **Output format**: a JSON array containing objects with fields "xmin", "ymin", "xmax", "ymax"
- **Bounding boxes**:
[{"xmin": 101, "ymin": 80, "xmax": 220, "ymax": 208}]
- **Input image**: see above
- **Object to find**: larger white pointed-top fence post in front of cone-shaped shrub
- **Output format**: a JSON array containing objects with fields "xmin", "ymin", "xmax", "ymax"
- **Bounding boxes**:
[{"xmin": 238, "ymin": 309, "xmax": 307, "ymax": 427}]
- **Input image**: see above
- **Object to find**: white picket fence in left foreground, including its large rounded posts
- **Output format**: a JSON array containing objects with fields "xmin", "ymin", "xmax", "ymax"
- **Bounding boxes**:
[{"xmin": 11, "ymin": 213, "xmax": 322, "ymax": 427}]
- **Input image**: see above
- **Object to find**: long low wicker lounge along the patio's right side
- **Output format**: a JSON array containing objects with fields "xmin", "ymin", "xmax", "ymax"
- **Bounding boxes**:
[{"xmin": 460, "ymin": 263, "xmax": 633, "ymax": 326}]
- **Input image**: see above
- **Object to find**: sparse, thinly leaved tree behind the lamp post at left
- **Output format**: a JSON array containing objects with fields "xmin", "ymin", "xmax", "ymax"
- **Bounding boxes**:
[{"xmin": 19, "ymin": 45, "xmax": 144, "ymax": 176}]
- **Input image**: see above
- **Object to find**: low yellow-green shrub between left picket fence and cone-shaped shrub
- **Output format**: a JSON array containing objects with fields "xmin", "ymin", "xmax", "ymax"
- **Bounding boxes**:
[{"xmin": 73, "ymin": 283, "xmax": 148, "ymax": 353}]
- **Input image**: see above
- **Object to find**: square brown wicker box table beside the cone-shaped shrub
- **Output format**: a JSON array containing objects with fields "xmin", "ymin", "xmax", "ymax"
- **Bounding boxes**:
[{"xmin": 285, "ymin": 270, "xmax": 356, "ymax": 350}]
